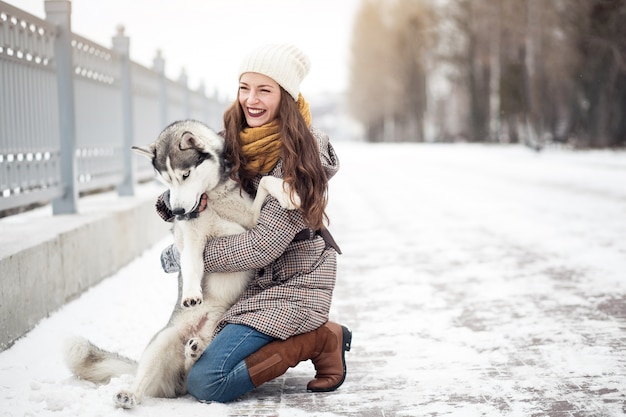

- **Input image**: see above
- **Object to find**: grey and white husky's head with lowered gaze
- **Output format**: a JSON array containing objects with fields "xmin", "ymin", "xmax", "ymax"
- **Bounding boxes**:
[{"xmin": 132, "ymin": 120, "xmax": 228, "ymax": 217}]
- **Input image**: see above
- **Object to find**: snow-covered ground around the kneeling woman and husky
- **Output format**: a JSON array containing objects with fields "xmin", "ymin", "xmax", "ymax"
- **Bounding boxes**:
[{"xmin": 0, "ymin": 143, "xmax": 626, "ymax": 417}]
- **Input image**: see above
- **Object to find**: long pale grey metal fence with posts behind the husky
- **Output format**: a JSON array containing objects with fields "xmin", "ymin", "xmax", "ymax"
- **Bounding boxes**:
[{"xmin": 0, "ymin": 0, "xmax": 225, "ymax": 214}]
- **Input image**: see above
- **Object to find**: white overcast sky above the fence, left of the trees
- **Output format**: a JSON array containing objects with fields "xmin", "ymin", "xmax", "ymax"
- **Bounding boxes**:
[{"xmin": 14, "ymin": 0, "xmax": 360, "ymax": 98}]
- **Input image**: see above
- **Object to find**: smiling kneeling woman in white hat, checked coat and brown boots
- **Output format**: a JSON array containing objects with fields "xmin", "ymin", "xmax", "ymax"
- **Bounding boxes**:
[{"xmin": 157, "ymin": 45, "xmax": 352, "ymax": 402}]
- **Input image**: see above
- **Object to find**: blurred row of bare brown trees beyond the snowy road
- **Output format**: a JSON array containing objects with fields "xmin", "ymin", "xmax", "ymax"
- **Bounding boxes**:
[{"xmin": 349, "ymin": 0, "xmax": 626, "ymax": 149}]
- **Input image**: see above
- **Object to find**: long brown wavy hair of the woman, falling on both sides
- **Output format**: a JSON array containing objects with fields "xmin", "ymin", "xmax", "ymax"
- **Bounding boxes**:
[{"xmin": 224, "ymin": 87, "xmax": 328, "ymax": 230}]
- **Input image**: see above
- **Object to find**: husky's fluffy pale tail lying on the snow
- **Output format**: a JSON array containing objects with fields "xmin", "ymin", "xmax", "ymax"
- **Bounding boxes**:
[{"xmin": 65, "ymin": 337, "xmax": 137, "ymax": 384}]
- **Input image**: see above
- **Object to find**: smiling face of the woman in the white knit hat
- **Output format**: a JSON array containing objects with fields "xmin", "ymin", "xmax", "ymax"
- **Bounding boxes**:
[{"xmin": 239, "ymin": 72, "xmax": 280, "ymax": 127}]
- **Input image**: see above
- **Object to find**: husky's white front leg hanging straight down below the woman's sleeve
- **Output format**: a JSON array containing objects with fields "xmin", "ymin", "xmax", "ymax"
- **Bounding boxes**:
[{"xmin": 178, "ymin": 220, "xmax": 206, "ymax": 308}]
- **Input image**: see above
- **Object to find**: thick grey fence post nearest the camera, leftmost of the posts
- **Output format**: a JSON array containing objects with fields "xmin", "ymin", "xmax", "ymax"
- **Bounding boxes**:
[{"xmin": 45, "ymin": 0, "xmax": 78, "ymax": 214}]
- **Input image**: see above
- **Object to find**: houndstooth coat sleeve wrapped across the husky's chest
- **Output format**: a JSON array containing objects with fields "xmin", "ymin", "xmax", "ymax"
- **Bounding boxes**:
[{"xmin": 204, "ymin": 196, "xmax": 306, "ymax": 272}]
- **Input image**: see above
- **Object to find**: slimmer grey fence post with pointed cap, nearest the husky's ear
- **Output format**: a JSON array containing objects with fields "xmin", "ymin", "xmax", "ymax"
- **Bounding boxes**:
[{"xmin": 113, "ymin": 25, "xmax": 135, "ymax": 196}]
